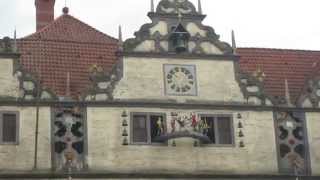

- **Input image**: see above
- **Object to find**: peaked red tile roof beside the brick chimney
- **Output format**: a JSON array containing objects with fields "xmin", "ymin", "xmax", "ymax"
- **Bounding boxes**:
[{"xmin": 18, "ymin": 14, "xmax": 117, "ymax": 98}]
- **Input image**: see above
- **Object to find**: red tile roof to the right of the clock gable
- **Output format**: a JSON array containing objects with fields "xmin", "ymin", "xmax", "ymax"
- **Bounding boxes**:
[{"xmin": 237, "ymin": 48, "xmax": 320, "ymax": 103}]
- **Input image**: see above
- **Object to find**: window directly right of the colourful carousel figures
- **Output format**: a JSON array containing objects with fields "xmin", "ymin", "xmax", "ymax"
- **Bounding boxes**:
[{"xmin": 200, "ymin": 115, "xmax": 234, "ymax": 145}]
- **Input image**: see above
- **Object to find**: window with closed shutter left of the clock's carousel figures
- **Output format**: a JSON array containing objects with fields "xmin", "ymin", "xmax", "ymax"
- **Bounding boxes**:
[{"xmin": 131, "ymin": 113, "xmax": 166, "ymax": 144}]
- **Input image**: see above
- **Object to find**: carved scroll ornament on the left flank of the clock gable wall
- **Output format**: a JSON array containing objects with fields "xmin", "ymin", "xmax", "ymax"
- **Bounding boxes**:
[{"xmin": 83, "ymin": 63, "xmax": 122, "ymax": 101}]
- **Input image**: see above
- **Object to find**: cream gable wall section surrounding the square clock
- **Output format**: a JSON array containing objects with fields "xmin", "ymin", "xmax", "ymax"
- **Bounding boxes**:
[{"xmin": 114, "ymin": 57, "xmax": 244, "ymax": 102}]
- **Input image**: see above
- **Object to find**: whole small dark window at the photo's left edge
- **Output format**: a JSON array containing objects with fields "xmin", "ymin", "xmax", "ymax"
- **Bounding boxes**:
[{"xmin": 0, "ymin": 112, "xmax": 19, "ymax": 144}]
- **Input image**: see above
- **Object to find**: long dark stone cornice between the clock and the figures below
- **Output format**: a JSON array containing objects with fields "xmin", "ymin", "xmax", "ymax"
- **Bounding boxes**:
[{"xmin": 0, "ymin": 99, "xmax": 320, "ymax": 112}]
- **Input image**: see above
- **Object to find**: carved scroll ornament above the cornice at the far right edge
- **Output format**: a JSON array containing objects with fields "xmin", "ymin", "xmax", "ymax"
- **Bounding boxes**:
[{"xmin": 298, "ymin": 76, "xmax": 320, "ymax": 108}]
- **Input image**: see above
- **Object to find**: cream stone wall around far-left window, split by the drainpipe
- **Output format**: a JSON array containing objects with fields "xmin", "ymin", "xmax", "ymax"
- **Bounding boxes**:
[{"xmin": 0, "ymin": 106, "xmax": 51, "ymax": 172}]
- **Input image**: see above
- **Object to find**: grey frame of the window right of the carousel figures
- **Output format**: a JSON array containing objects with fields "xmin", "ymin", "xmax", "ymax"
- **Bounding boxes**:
[{"xmin": 198, "ymin": 113, "xmax": 236, "ymax": 147}]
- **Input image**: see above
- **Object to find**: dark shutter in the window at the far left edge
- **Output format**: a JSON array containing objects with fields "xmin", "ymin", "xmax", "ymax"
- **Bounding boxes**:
[{"xmin": 2, "ymin": 114, "xmax": 17, "ymax": 143}]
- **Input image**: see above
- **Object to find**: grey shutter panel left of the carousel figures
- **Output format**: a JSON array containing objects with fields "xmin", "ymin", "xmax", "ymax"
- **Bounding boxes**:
[{"xmin": 132, "ymin": 115, "xmax": 148, "ymax": 143}]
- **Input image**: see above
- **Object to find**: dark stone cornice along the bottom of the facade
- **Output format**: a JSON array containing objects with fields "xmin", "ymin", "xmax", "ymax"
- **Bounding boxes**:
[{"xmin": 0, "ymin": 171, "xmax": 320, "ymax": 180}]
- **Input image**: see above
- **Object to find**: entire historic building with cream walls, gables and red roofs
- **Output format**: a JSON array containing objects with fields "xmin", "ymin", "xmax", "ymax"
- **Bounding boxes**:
[{"xmin": 0, "ymin": 0, "xmax": 320, "ymax": 179}]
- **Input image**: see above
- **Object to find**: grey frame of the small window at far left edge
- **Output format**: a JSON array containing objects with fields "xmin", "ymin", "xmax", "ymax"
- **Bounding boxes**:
[{"xmin": 0, "ymin": 111, "xmax": 20, "ymax": 145}]
